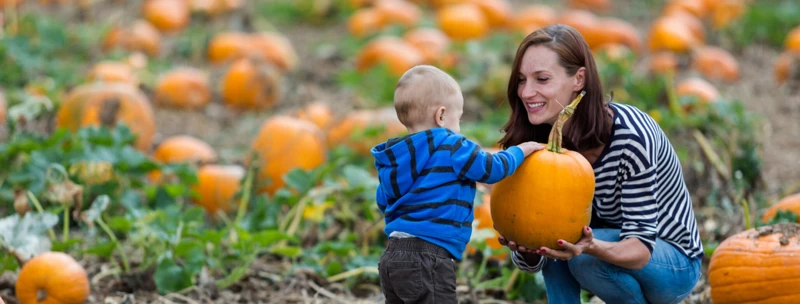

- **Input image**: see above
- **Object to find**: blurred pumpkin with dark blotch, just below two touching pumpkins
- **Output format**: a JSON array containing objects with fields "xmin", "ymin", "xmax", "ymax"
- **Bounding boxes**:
[{"xmin": 222, "ymin": 58, "xmax": 282, "ymax": 109}]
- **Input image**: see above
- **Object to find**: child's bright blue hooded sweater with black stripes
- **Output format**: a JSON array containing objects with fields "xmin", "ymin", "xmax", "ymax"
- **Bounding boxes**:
[{"xmin": 372, "ymin": 128, "xmax": 525, "ymax": 260}]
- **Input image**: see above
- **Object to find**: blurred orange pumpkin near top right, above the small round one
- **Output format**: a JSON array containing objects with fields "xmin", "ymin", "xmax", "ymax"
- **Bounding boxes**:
[{"xmin": 647, "ymin": 16, "xmax": 699, "ymax": 53}]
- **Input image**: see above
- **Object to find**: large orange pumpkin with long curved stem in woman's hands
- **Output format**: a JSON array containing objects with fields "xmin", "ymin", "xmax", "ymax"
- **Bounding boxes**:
[{"xmin": 491, "ymin": 93, "xmax": 595, "ymax": 249}]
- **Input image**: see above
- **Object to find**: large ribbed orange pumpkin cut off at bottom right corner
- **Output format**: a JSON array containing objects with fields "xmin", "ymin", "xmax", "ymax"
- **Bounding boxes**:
[{"xmin": 708, "ymin": 223, "xmax": 800, "ymax": 304}]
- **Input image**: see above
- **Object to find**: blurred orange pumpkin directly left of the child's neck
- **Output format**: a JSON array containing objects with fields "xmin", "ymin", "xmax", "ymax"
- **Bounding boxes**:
[{"xmin": 328, "ymin": 107, "xmax": 407, "ymax": 156}]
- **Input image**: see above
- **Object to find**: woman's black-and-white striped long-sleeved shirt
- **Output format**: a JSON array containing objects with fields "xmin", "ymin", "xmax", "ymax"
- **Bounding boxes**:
[{"xmin": 511, "ymin": 103, "xmax": 703, "ymax": 272}]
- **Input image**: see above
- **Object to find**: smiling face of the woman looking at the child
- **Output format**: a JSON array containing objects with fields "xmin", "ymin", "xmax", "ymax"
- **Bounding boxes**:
[{"xmin": 517, "ymin": 45, "xmax": 586, "ymax": 125}]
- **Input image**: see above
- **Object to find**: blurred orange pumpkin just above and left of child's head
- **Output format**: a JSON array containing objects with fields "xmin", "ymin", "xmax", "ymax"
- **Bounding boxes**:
[{"xmin": 356, "ymin": 36, "xmax": 423, "ymax": 77}]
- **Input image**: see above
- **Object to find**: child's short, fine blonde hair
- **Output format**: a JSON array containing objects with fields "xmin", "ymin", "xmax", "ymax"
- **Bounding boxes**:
[{"xmin": 394, "ymin": 65, "xmax": 461, "ymax": 126}]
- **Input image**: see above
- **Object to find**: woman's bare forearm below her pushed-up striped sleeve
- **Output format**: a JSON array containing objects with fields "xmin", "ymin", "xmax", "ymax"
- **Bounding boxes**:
[{"xmin": 584, "ymin": 238, "xmax": 650, "ymax": 270}]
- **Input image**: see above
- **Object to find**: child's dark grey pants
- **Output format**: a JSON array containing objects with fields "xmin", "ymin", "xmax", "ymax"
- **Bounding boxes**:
[{"xmin": 378, "ymin": 238, "xmax": 458, "ymax": 304}]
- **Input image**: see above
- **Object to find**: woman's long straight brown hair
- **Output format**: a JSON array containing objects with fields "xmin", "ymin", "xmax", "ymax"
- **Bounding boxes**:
[{"xmin": 498, "ymin": 24, "xmax": 611, "ymax": 152}]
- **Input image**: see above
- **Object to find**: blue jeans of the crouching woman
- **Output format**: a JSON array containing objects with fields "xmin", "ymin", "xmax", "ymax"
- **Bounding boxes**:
[{"xmin": 542, "ymin": 229, "xmax": 701, "ymax": 304}]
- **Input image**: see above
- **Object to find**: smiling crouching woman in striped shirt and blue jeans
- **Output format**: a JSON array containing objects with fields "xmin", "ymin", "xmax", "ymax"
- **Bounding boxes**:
[{"xmin": 499, "ymin": 25, "xmax": 703, "ymax": 303}]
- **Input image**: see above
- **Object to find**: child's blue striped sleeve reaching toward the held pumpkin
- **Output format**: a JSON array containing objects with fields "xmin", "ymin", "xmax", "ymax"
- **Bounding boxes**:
[{"xmin": 451, "ymin": 137, "xmax": 525, "ymax": 184}]
